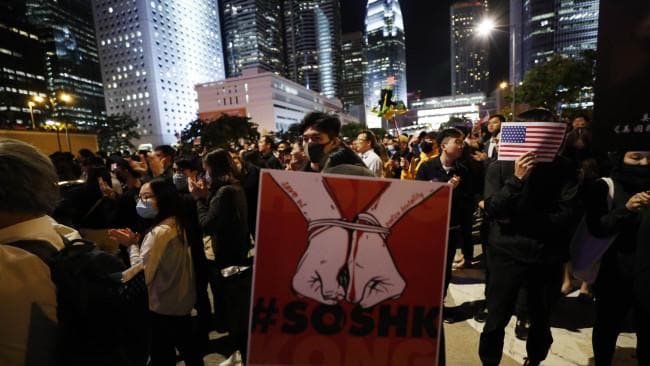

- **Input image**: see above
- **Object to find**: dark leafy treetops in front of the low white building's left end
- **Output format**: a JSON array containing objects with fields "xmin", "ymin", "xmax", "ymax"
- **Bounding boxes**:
[{"xmin": 180, "ymin": 114, "xmax": 260, "ymax": 154}]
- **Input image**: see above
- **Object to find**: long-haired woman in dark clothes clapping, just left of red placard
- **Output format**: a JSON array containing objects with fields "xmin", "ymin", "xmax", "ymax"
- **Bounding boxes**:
[{"xmin": 189, "ymin": 149, "xmax": 252, "ymax": 365}]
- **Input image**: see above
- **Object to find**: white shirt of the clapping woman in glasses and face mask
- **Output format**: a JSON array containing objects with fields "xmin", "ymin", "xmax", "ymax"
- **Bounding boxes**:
[{"xmin": 122, "ymin": 218, "xmax": 196, "ymax": 315}]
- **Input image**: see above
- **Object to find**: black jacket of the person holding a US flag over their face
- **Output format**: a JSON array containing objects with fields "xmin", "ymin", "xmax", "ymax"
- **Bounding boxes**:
[{"xmin": 484, "ymin": 157, "xmax": 579, "ymax": 263}]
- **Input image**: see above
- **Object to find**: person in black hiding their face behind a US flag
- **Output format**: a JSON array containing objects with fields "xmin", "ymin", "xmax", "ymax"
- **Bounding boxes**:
[{"xmin": 479, "ymin": 109, "xmax": 578, "ymax": 365}]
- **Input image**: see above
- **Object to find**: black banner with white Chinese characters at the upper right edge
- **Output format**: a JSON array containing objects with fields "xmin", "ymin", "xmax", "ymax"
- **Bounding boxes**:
[{"xmin": 593, "ymin": 0, "xmax": 650, "ymax": 151}]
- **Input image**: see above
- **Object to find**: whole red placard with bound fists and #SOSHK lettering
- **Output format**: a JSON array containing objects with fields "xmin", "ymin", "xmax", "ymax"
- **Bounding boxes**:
[{"xmin": 248, "ymin": 170, "xmax": 451, "ymax": 366}]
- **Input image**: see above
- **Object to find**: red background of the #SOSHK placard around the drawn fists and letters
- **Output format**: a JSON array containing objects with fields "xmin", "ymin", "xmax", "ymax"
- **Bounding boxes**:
[{"xmin": 248, "ymin": 171, "xmax": 451, "ymax": 366}]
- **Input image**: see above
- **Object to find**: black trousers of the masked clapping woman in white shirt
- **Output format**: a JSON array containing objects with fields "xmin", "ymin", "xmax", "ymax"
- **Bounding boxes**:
[{"xmin": 149, "ymin": 312, "xmax": 203, "ymax": 366}]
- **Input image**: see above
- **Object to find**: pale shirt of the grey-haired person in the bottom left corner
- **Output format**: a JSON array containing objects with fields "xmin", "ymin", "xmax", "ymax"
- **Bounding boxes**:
[{"xmin": 0, "ymin": 216, "xmax": 63, "ymax": 366}]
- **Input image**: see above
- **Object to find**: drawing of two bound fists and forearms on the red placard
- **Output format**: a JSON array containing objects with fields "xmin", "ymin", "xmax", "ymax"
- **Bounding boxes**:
[{"xmin": 270, "ymin": 172, "xmax": 439, "ymax": 308}]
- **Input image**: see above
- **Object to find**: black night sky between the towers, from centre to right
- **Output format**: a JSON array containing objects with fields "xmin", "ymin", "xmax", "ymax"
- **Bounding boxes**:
[{"xmin": 341, "ymin": 0, "xmax": 509, "ymax": 97}]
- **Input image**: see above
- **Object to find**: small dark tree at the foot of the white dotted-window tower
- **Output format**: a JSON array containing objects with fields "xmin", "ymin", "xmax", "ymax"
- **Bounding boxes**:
[{"xmin": 97, "ymin": 114, "xmax": 140, "ymax": 152}]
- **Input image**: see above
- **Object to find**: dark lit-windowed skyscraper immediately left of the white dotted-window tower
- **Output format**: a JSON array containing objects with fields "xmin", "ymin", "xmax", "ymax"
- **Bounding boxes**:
[{"xmin": 26, "ymin": 0, "xmax": 106, "ymax": 129}]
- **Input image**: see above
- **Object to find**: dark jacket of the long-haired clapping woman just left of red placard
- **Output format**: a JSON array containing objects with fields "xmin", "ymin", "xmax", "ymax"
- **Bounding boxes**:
[{"xmin": 196, "ymin": 184, "xmax": 250, "ymax": 268}]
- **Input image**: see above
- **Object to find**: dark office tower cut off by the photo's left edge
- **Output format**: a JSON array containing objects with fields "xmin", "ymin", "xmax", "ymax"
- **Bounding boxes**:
[{"xmin": 0, "ymin": 0, "xmax": 47, "ymax": 126}]
